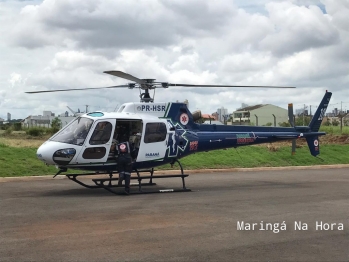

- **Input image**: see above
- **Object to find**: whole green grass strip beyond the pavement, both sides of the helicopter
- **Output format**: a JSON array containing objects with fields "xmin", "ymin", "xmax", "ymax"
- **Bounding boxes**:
[{"xmin": 0, "ymin": 143, "xmax": 349, "ymax": 177}]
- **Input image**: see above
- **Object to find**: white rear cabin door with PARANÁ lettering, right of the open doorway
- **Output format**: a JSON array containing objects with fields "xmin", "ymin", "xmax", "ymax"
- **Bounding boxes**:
[{"xmin": 137, "ymin": 122, "xmax": 167, "ymax": 162}]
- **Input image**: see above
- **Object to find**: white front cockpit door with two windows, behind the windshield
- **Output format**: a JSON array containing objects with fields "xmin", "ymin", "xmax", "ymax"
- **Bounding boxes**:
[{"xmin": 76, "ymin": 119, "xmax": 115, "ymax": 164}]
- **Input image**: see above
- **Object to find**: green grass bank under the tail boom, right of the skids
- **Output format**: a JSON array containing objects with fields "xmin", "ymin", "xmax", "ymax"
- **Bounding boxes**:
[{"xmin": 174, "ymin": 144, "xmax": 349, "ymax": 169}]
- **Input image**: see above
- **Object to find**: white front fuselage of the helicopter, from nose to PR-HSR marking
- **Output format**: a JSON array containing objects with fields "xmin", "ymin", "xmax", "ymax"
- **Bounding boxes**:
[{"xmin": 37, "ymin": 103, "xmax": 173, "ymax": 167}]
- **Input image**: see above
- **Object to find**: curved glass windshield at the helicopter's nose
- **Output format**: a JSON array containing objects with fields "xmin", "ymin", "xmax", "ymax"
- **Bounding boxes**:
[{"xmin": 51, "ymin": 117, "xmax": 93, "ymax": 145}]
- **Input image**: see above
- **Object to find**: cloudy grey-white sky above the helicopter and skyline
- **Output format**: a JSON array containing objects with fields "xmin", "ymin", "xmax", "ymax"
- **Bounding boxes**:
[{"xmin": 0, "ymin": 0, "xmax": 349, "ymax": 119}]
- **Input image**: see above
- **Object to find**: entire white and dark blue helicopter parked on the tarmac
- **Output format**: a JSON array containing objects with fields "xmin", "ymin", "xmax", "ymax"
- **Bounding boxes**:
[{"xmin": 26, "ymin": 71, "xmax": 332, "ymax": 194}]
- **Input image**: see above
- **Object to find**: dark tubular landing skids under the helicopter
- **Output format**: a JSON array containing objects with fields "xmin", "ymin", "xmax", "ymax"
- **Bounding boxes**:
[{"xmin": 54, "ymin": 160, "xmax": 191, "ymax": 195}]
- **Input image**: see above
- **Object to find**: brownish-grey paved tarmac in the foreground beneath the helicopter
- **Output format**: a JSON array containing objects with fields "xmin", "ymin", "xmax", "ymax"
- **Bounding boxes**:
[{"xmin": 0, "ymin": 168, "xmax": 349, "ymax": 261}]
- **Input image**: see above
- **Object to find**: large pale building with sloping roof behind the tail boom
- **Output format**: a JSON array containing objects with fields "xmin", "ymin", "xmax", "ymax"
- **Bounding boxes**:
[{"xmin": 233, "ymin": 104, "xmax": 288, "ymax": 126}]
